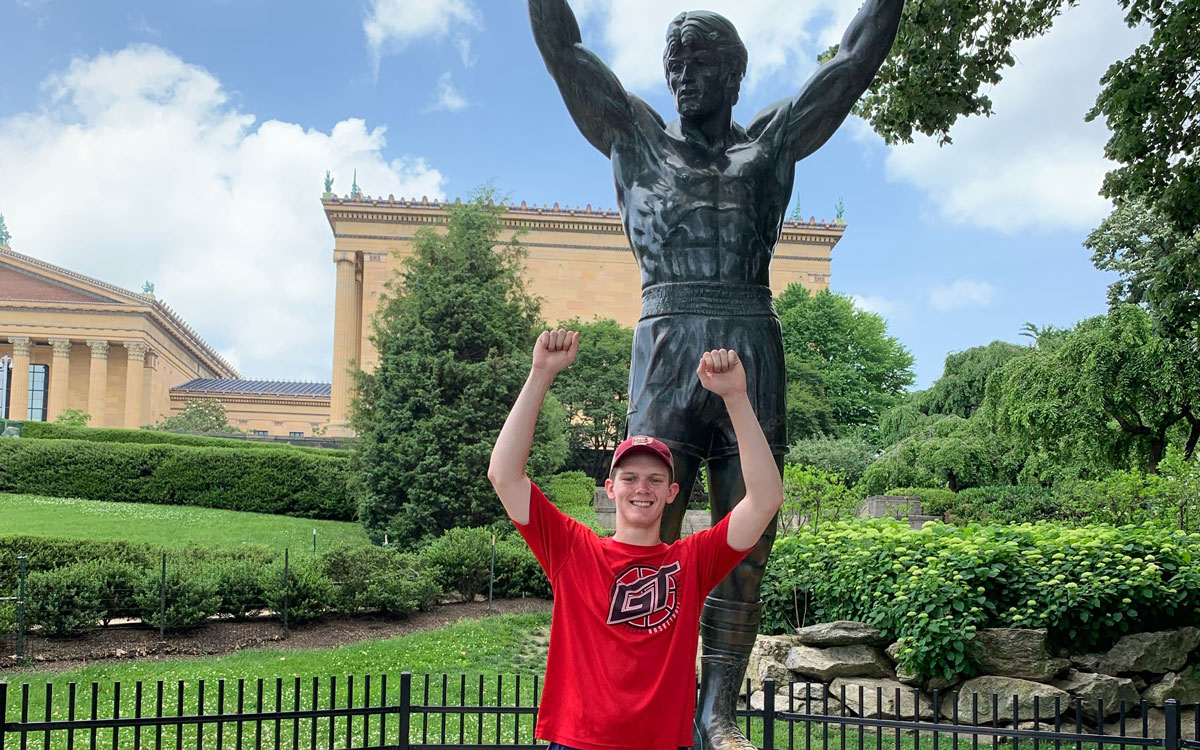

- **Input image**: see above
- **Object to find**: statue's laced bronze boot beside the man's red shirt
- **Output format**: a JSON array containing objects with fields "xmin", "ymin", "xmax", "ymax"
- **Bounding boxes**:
[{"xmin": 692, "ymin": 596, "xmax": 762, "ymax": 750}]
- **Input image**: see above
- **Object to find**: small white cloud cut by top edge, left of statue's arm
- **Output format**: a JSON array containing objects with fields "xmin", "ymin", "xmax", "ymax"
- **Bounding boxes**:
[{"xmin": 362, "ymin": 0, "xmax": 481, "ymax": 67}]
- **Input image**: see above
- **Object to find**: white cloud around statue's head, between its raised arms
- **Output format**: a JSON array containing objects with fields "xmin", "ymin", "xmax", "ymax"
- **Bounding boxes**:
[{"xmin": 571, "ymin": 0, "xmax": 860, "ymax": 92}]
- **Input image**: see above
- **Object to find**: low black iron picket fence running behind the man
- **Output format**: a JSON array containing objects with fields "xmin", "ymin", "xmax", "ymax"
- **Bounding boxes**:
[{"xmin": 0, "ymin": 672, "xmax": 1200, "ymax": 750}]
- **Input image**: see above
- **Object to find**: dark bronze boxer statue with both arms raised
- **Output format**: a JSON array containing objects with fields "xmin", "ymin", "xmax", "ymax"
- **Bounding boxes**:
[{"xmin": 529, "ymin": 0, "xmax": 904, "ymax": 749}]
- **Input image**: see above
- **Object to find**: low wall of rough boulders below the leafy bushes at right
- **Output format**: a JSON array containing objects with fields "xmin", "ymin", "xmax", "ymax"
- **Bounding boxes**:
[{"xmin": 746, "ymin": 622, "xmax": 1200, "ymax": 739}]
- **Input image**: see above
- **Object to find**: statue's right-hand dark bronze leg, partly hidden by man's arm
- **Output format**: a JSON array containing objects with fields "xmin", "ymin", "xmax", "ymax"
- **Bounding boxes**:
[{"xmin": 694, "ymin": 455, "xmax": 784, "ymax": 750}]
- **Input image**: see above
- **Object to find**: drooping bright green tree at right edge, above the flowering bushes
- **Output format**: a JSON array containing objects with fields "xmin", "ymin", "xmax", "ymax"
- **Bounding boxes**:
[{"xmin": 986, "ymin": 305, "xmax": 1200, "ymax": 475}]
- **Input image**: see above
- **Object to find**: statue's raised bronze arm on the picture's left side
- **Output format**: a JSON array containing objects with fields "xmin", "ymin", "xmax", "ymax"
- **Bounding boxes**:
[{"xmin": 529, "ymin": 0, "xmax": 644, "ymax": 156}]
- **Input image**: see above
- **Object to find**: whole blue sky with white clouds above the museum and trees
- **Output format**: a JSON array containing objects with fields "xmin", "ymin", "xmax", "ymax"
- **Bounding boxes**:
[{"xmin": 0, "ymin": 0, "xmax": 1145, "ymax": 386}]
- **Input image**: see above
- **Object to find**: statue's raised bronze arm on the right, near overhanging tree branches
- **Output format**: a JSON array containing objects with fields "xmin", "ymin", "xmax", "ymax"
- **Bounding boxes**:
[{"xmin": 749, "ymin": 0, "xmax": 904, "ymax": 161}]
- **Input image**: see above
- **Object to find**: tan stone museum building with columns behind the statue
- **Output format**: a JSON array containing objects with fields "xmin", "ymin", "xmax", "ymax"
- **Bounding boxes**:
[{"xmin": 0, "ymin": 193, "xmax": 845, "ymax": 437}]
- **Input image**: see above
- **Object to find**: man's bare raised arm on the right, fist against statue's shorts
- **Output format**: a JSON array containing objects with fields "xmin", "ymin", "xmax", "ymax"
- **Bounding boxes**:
[{"xmin": 696, "ymin": 349, "xmax": 784, "ymax": 551}]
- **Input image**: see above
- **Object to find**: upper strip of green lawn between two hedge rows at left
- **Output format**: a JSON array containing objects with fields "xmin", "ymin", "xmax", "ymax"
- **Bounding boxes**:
[{"xmin": 0, "ymin": 493, "xmax": 368, "ymax": 552}]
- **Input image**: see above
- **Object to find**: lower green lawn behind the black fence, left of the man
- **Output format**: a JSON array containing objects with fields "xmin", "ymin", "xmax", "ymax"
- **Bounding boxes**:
[{"xmin": 0, "ymin": 614, "xmax": 550, "ymax": 748}]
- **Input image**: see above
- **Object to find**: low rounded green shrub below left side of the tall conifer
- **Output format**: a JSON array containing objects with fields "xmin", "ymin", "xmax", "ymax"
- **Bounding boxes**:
[{"xmin": 320, "ymin": 547, "xmax": 442, "ymax": 616}]
